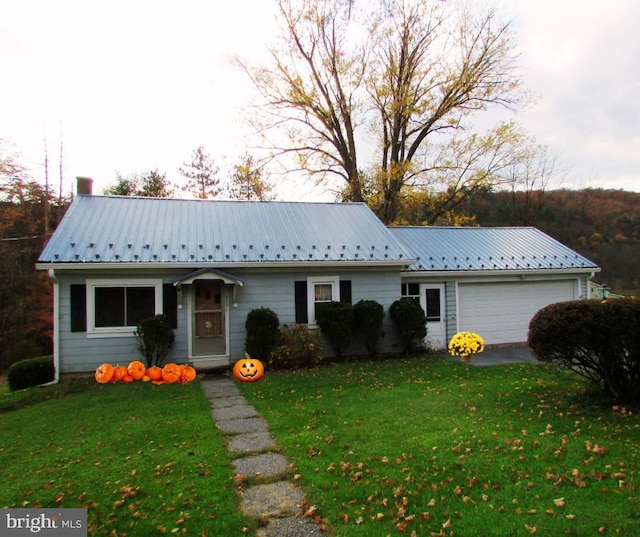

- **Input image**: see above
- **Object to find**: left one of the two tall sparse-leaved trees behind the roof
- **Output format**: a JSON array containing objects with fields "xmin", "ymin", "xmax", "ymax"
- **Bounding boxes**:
[{"xmin": 240, "ymin": 0, "xmax": 369, "ymax": 201}]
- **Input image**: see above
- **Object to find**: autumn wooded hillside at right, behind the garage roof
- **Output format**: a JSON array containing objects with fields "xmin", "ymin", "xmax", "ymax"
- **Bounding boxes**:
[{"xmin": 463, "ymin": 189, "xmax": 640, "ymax": 294}]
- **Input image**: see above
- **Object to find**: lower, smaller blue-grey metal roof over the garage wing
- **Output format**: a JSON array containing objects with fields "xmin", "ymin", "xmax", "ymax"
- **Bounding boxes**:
[{"xmin": 389, "ymin": 226, "xmax": 598, "ymax": 271}]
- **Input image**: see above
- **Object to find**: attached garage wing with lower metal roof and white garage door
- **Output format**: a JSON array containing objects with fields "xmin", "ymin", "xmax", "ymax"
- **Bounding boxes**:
[{"xmin": 389, "ymin": 227, "xmax": 600, "ymax": 349}]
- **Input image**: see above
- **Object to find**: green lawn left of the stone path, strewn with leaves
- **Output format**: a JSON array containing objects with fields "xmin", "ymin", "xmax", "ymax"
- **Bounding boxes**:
[{"xmin": 0, "ymin": 379, "xmax": 255, "ymax": 537}]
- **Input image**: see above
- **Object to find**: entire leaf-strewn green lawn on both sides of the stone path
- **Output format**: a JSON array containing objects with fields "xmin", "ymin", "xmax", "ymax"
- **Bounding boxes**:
[{"xmin": 0, "ymin": 356, "xmax": 640, "ymax": 537}]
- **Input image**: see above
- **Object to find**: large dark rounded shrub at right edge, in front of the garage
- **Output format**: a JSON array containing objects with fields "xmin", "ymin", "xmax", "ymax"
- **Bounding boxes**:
[{"xmin": 528, "ymin": 299, "xmax": 640, "ymax": 403}]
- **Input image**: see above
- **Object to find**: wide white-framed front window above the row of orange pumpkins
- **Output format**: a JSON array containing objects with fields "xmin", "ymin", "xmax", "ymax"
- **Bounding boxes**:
[{"xmin": 87, "ymin": 279, "xmax": 162, "ymax": 336}]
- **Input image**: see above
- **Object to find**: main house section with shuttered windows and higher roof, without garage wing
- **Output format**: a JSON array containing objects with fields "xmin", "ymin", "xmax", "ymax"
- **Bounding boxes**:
[{"xmin": 36, "ymin": 186, "xmax": 413, "ymax": 373}]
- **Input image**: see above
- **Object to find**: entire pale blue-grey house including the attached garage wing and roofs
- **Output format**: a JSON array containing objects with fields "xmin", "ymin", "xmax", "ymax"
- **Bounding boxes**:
[{"xmin": 36, "ymin": 178, "xmax": 598, "ymax": 374}]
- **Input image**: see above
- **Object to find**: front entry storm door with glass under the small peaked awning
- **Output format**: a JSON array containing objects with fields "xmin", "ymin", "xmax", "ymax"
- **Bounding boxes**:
[{"xmin": 191, "ymin": 280, "xmax": 227, "ymax": 357}]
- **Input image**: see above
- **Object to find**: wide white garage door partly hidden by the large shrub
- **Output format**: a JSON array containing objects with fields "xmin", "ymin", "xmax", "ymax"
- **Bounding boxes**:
[{"xmin": 458, "ymin": 280, "xmax": 577, "ymax": 344}]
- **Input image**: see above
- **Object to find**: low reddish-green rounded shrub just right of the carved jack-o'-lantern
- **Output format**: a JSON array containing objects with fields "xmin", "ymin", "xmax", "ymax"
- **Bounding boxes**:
[{"xmin": 267, "ymin": 324, "xmax": 324, "ymax": 369}]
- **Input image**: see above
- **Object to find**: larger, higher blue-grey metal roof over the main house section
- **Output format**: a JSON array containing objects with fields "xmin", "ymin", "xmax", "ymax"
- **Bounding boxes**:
[{"xmin": 38, "ymin": 196, "xmax": 413, "ymax": 268}]
